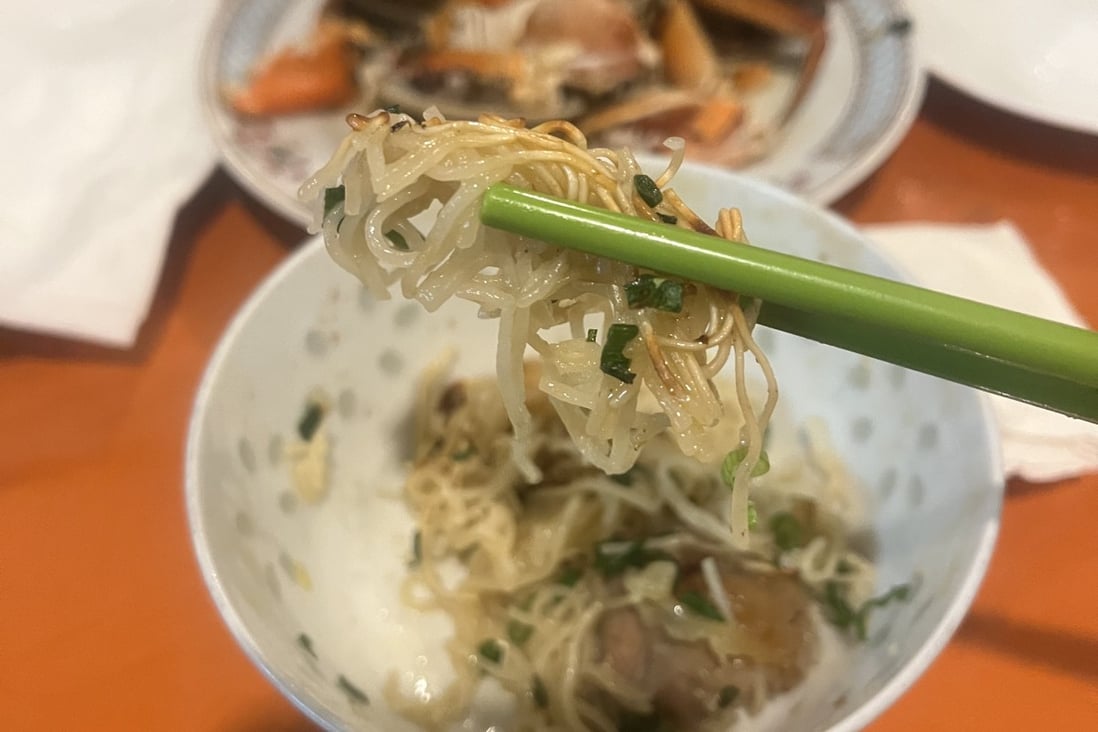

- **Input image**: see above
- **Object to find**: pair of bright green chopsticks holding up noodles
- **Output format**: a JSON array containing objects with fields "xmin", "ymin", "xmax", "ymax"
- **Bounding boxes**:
[{"xmin": 481, "ymin": 183, "xmax": 1098, "ymax": 423}]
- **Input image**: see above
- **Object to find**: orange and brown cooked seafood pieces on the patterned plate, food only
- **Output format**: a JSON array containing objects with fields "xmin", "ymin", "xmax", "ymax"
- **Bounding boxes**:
[{"xmin": 226, "ymin": 0, "xmax": 827, "ymax": 165}]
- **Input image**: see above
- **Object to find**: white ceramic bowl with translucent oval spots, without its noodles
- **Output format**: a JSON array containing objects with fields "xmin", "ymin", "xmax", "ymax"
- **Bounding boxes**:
[{"xmin": 186, "ymin": 167, "xmax": 1002, "ymax": 732}]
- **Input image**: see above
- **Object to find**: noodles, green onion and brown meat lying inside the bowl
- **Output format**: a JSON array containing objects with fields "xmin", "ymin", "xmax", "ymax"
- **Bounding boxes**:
[{"xmin": 386, "ymin": 375, "xmax": 873, "ymax": 732}]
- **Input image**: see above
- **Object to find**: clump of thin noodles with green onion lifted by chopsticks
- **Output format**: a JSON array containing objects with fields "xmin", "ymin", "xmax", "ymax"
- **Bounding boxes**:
[{"xmin": 300, "ymin": 105, "xmax": 777, "ymax": 549}]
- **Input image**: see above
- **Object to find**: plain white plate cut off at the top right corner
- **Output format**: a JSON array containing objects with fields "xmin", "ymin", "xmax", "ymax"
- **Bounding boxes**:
[{"xmin": 910, "ymin": 0, "xmax": 1098, "ymax": 134}]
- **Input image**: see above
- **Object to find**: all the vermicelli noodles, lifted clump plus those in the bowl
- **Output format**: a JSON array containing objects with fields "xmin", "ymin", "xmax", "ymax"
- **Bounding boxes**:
[{"xmin": 302, "ymin": 112, "xmax": 898, "ymax": 732}]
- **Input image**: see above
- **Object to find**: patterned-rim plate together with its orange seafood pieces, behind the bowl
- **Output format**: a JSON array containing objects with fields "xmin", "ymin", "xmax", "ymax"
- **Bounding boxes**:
[{"xmin": 202, "ymin": 0, "xmax": 922, "ymax": 220}]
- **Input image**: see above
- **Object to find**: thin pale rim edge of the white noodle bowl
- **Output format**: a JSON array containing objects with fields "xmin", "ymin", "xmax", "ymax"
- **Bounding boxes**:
[{"xmin": 183, "ymin": 167, "xmax": 1006, "ymax": 732}]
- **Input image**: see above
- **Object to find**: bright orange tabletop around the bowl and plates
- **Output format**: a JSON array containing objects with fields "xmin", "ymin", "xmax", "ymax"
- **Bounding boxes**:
[{"xmin": 0, "ymin": 83, "xmax": 1098, "ymax": 732}]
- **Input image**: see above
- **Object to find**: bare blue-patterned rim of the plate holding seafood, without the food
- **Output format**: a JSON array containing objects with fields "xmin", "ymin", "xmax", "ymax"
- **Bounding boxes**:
[{"xmin": 202, "ymin": 0, "xmax": 925, "ymax": 226}]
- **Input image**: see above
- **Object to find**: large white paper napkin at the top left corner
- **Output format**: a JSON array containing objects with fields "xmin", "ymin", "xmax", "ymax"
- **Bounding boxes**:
[{"xmin": 0, "ymin": 0, "xmax": 217, "ymax": 347}]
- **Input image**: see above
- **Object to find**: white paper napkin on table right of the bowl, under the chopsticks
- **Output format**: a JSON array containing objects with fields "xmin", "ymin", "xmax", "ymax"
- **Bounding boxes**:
[{"xmin": 864, "ymin": 222, "xmax": 1098, "ymax": 482}]
